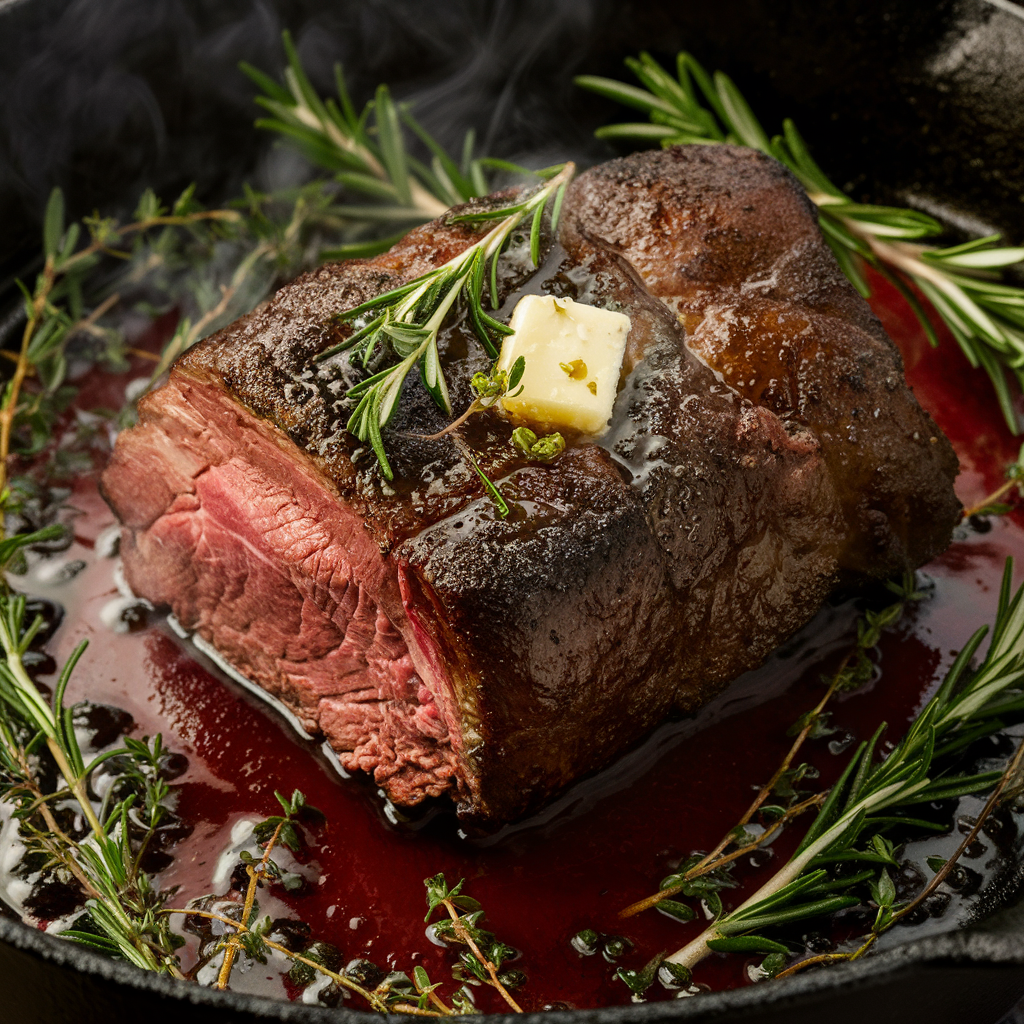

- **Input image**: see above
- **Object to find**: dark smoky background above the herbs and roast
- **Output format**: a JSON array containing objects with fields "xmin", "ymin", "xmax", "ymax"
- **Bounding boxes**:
[{"xmin": 0, "ymin": 0, "xmax": 1024, "ymax": 302}]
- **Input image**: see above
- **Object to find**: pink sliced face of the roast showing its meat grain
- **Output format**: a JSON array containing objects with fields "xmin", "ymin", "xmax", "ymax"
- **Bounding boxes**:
[{"xmin": 104, "ymin": 374, "xmax": 460, "ymax": 804}]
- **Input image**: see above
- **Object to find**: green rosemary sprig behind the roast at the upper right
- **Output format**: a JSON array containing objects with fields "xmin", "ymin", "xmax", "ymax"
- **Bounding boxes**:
[{"xmin": 575, "ymin": 53, "xmax": 1024, "ymax": 433}]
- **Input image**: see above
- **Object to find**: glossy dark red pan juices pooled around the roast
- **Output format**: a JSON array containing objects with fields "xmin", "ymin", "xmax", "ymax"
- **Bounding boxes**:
[{"xmin": 0, "ymin": 275, "xmax": 1024, "ymax": 1012}]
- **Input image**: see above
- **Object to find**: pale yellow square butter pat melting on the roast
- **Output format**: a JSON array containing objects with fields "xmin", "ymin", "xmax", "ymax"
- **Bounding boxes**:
[{"xmin": 498, "ymin": 295, "xmax": 630, "ymax": 435}]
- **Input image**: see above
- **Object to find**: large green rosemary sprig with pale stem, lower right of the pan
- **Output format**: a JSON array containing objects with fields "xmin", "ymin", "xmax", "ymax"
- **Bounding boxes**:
[{"xmin": 667, "ymin": 559, "xmax": 1024, "ymax": 969}]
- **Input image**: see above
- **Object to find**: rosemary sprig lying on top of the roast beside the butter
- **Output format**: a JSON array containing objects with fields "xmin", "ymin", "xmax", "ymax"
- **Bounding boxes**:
[{"xmin": 316, "ymin": 164, "xmax": 574, "ymax": 480}]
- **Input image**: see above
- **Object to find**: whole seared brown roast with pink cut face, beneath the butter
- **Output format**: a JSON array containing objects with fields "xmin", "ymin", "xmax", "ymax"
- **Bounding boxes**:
[{"xmin": 102, "ymin": 145, "xmax": 959, "ymax": 828}]
